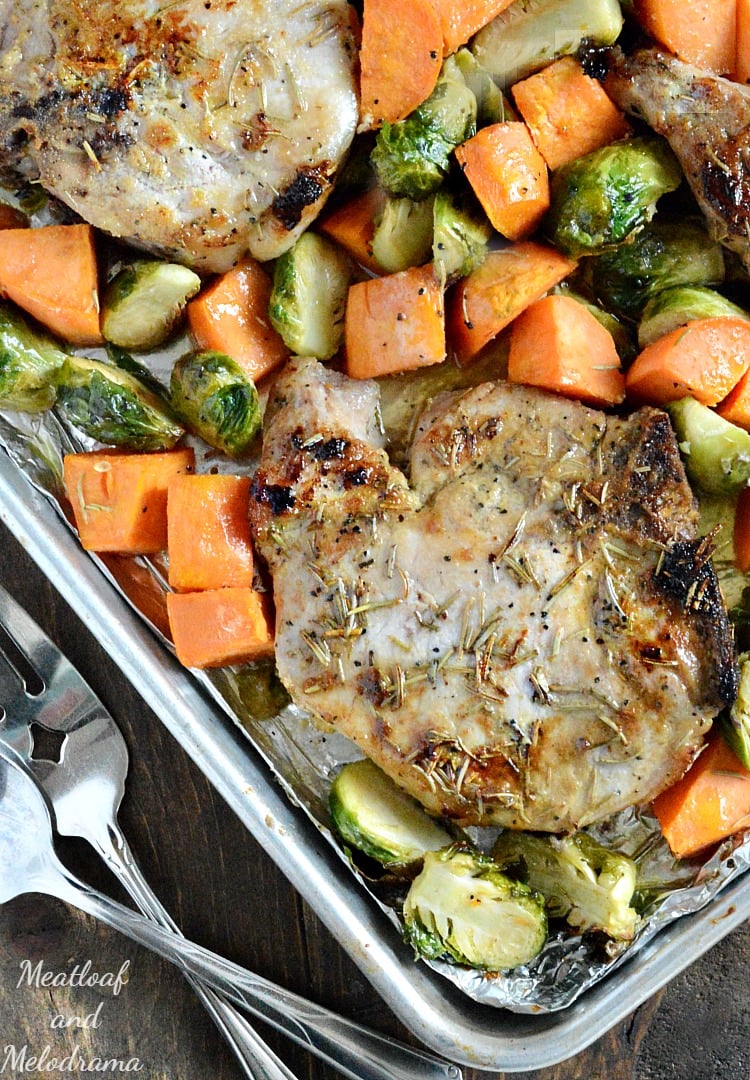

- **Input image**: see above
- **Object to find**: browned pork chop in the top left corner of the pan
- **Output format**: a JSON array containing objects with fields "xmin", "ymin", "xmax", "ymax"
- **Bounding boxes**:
[{"xmin": 0, "ymin": 0, "xmax": 358, "ymax": 270}]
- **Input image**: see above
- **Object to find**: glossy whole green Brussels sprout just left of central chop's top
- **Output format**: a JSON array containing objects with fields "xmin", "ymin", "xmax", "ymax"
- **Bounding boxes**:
[{"xmin": 170, "ymin": 351, "xmax": 263, "ymax": 458}]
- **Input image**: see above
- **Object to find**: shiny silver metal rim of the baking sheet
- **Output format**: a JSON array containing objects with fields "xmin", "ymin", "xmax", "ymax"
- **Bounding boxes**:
[{"xmin": 0, "ymin": 453, "xmax": 750, "ymax": 1072}]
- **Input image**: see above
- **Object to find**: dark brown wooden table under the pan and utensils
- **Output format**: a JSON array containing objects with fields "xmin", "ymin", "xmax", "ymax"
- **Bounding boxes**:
[{"xmin": 0, "ymin": 527, "xmax": 750, "ymax": 1080}]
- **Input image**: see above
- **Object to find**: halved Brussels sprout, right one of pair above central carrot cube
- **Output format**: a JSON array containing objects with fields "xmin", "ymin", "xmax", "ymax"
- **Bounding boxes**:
[{"xmin": 432, "ymin": 191, "xmax": 493, "ymax": 281}]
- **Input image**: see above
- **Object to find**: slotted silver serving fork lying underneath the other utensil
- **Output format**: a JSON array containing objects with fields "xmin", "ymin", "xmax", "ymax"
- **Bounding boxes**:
[{"xmin": 0, "ymin": 588, "xmax": 296, "ymax": 1080}]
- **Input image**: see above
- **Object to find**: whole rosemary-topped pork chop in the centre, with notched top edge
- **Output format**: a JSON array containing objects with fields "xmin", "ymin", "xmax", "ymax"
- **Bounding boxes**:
[{"xmin": 251, "ymin": 360, "xmax": 736, "ymax": 832}]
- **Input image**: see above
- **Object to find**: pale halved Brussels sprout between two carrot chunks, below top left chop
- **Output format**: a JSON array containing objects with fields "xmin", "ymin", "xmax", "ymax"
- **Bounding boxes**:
[{"xmin": 102, "ymin": 259, "xmax": 201, "ymax": 349}]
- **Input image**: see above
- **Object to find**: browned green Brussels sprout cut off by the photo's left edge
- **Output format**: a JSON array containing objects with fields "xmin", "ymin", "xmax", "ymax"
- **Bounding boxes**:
[{"xmin": 0, "ymin": 301, "xmax": 67, "ymax": 413}]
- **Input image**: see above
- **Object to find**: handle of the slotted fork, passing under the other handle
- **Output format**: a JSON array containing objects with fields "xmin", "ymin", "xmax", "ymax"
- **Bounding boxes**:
[{"xmin": 96, "ymin": 824, "xmax": 297, "ymax": 1080}]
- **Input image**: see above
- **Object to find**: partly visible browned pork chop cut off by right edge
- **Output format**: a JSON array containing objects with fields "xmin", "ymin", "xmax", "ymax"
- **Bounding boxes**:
[{"xmin": 604, "ymin": 48, "xmax": 750, "ymax": 270}]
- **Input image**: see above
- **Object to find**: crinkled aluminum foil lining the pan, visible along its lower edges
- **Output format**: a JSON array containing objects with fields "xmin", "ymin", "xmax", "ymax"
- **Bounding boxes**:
[{"xmin": 0, "ymin": 390, "xmax": 750, "ymax": 1015}]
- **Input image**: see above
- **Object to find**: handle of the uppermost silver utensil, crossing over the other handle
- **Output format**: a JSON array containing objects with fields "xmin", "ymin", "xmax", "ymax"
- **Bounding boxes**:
[{"xmin": 49, "ymin": 865, "xmax": 461, "ymax": 1080}]
